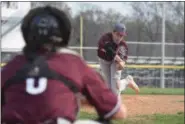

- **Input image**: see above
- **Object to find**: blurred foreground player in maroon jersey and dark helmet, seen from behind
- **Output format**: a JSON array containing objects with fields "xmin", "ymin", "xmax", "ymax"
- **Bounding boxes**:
[{"xmin": 1, "ymin": 7, "xmax": 126, "ymax": 124}]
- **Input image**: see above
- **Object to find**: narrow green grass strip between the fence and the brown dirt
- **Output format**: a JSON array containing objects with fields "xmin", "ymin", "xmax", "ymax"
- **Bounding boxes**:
[{"xmin": 122, "ymin": 87, "xmax": 184, "ymax": 95}]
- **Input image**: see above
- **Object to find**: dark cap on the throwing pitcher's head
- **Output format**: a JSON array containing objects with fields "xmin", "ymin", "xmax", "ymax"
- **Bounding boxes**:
[{"xmin": 113, "ymin": 23, "xmax": 126, "ymax": 36}]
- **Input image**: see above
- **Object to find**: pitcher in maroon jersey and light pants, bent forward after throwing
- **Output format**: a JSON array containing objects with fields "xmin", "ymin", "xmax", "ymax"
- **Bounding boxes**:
[{"xmin": 97, "ymin": 23, "xmax": 139, "ymax": 94}]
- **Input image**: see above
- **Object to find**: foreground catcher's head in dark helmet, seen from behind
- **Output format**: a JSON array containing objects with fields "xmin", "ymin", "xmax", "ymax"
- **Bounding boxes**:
[{"xmin": 21, "ymin": 6, "xmax": 71, "ymax": 51}]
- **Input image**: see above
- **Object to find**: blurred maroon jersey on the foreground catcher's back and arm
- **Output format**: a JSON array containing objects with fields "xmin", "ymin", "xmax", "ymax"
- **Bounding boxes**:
[{"xmin": 1, "ymin": 49, "xmax": 120, "ymax": 124}]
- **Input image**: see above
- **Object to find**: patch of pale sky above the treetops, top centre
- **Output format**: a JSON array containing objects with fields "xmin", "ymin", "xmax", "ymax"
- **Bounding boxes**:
[{"xmin": 66, "ymin": 2, "xmax": 131, "ymax": 15}]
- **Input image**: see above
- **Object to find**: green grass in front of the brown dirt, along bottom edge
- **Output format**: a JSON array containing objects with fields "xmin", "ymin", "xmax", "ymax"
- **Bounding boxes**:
[{"xmin": 79, "ymin": 112, "xmax": 184, "ymax": 124}]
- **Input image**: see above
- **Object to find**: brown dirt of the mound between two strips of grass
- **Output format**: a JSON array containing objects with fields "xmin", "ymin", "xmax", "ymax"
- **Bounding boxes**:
[{"xmin": 82, "ymin": 95, "xmax": 184, "ymax": 116}]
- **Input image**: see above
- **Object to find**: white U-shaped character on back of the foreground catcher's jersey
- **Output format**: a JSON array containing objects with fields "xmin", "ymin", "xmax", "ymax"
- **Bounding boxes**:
[{"xmin": 26, "ymin": 78, "xmax": 47, "ymax": 95}]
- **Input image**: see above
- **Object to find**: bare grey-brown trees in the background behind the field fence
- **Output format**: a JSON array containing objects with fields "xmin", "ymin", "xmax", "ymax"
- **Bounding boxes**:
[{"xmin": 31, "ymin": 2, "xmax": 184, "ymax": 56}]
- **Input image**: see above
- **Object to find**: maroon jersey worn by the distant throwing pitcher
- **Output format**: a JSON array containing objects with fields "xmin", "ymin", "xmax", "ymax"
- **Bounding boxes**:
[{"xmin": 97, "ymin": 32, "xmax": 128, "ymax": 61}]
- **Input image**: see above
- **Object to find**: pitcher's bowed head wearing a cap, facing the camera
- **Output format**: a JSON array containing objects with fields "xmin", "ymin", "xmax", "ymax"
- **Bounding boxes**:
[{"xmin": 112, "ymin": 23, "xmax": 126, "ymax": 44}]
